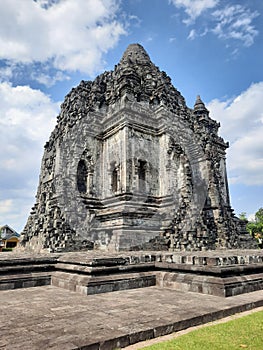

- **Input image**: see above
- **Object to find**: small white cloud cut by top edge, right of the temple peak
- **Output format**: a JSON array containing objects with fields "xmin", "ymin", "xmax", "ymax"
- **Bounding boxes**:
[{"xmin": 170, "ymin": 0, "xmax": 218, "ymax": 24}]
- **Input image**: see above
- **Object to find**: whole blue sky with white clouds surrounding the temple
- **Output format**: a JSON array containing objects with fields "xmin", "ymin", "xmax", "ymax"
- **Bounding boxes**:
[{"xmin": 0, "ymin": 0, "xmax": 263, "ymax": 231}]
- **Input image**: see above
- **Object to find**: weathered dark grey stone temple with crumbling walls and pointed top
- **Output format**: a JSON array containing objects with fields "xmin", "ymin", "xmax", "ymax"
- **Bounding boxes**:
[{"xmin": 22, "ymin": 44, "xmax": 255, "ymax": 252}]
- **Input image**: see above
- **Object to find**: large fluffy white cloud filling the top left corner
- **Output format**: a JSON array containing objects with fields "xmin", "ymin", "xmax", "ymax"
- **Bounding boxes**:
[{"xmin": 0, "ymin": 0, "xmax": 125, "ymax": 74}]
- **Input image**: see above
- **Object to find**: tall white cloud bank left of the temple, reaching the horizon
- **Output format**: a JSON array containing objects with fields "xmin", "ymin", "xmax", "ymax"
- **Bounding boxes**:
[{"xmin": 0, "ymin": 83, "xmax": 59, "ymax": 229}]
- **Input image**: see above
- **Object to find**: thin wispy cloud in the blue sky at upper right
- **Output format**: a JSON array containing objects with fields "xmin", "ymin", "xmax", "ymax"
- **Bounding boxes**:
[{"xmin": 212, "ymin": 5, "xmax": 259, "ymax": 47}]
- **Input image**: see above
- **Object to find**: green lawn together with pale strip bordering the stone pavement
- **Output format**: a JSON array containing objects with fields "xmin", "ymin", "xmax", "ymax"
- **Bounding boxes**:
[{"xmin": 125, "ymin": 307, "xmax": 263, "ymax": 350}]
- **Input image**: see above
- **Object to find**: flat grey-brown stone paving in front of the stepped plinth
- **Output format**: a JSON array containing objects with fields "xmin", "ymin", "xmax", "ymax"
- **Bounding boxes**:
[{"xmin": 0, "ymin": 286, "xmax": 263, "ymax": 350}]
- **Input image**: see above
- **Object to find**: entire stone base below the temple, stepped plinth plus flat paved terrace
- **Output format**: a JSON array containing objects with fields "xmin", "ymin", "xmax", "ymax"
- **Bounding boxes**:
[{"xmin": 0, "ymin": 250, "xmax": 263, "ymax": 350}]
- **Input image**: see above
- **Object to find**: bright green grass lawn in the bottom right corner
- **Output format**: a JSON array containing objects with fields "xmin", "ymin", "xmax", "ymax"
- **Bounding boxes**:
[{"xmin": 143, "ymin": 311, "xmax": 263, "ymax": 350}]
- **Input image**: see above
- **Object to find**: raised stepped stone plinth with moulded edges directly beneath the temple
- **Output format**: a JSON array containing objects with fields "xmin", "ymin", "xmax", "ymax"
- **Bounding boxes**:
[{"xmin": 0, "ymin": 250, "xmax": 263, "ymax": 297}]
